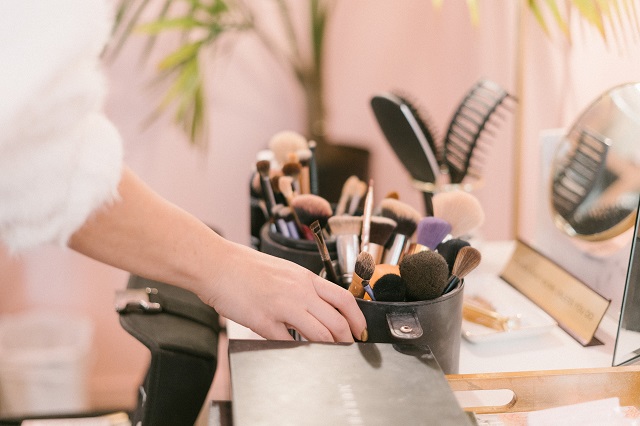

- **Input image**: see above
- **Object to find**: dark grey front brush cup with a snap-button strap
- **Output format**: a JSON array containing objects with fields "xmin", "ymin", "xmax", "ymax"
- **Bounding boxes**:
[{"xmin": 320, "ymin": 264, "xmax": 464, "ymax": 374}]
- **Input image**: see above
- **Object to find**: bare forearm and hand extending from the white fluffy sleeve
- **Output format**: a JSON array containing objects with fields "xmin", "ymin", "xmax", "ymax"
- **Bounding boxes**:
[{"xmin": 69, "ymin": 167, "xmax": 366, "ymax": 341}]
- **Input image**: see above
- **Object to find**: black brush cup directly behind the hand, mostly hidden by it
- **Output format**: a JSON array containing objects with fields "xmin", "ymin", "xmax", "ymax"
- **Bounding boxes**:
[{"xmin": 260, "ymin": 223, "xmax": 337, "ymax": 274}]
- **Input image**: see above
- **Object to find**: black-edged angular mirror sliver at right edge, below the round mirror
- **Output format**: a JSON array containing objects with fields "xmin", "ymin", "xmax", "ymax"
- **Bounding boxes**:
[{"xmin": 613, "ymin": 200, "xmax": 640, "ymax": 366}]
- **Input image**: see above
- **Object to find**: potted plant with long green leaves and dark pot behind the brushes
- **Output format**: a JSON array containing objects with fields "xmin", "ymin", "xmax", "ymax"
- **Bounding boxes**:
[{"xmin": 108, "ymin": 0, "xmax": 369, "ymax": 201}]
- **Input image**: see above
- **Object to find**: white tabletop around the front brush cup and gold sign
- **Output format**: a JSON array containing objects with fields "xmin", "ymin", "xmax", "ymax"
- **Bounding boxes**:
[{"xmin": 227, "ymin": 241, "xmax": 617, "ymax": 374}]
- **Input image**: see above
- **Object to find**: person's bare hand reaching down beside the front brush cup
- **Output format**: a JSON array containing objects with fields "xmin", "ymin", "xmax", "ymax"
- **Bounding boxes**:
[{"xmin": 199, "ymin": 241, "xmax": 367, "ymax": 342}]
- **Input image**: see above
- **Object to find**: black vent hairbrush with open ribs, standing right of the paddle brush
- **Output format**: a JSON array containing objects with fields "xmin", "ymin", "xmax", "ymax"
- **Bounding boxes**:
[{"xmin": 443, "ymin": 80, "xmax": 515, "ymax": 183}]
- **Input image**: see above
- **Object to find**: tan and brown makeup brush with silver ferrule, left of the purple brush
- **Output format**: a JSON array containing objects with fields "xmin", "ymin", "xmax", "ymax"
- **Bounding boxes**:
[{"xmin": 380, "ymin": 198, "xmax": 422, "ymax": 265}]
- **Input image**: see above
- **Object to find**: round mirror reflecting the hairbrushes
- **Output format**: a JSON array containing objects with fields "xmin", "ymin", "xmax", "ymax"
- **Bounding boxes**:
[{"xmin": 550, "ymin": 83, "xmax": 640, "ymax": 241}]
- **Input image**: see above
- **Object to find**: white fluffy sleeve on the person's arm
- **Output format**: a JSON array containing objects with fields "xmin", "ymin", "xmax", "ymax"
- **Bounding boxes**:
[{"xmin": 0, "ymin": 0, "xmax": 122, "ymax": 252}]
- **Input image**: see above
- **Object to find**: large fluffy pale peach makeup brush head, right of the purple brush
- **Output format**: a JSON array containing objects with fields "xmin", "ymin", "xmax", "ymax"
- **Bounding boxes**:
[{"xmin": 433, "ymin": 190, "xmax": 485, "ymax": 238}]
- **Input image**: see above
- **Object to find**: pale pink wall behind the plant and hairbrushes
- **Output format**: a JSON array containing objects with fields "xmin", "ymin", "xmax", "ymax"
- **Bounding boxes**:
[{"xmin": 0, "ymin": 0, "xmax": 636, "ymax": 412}]
